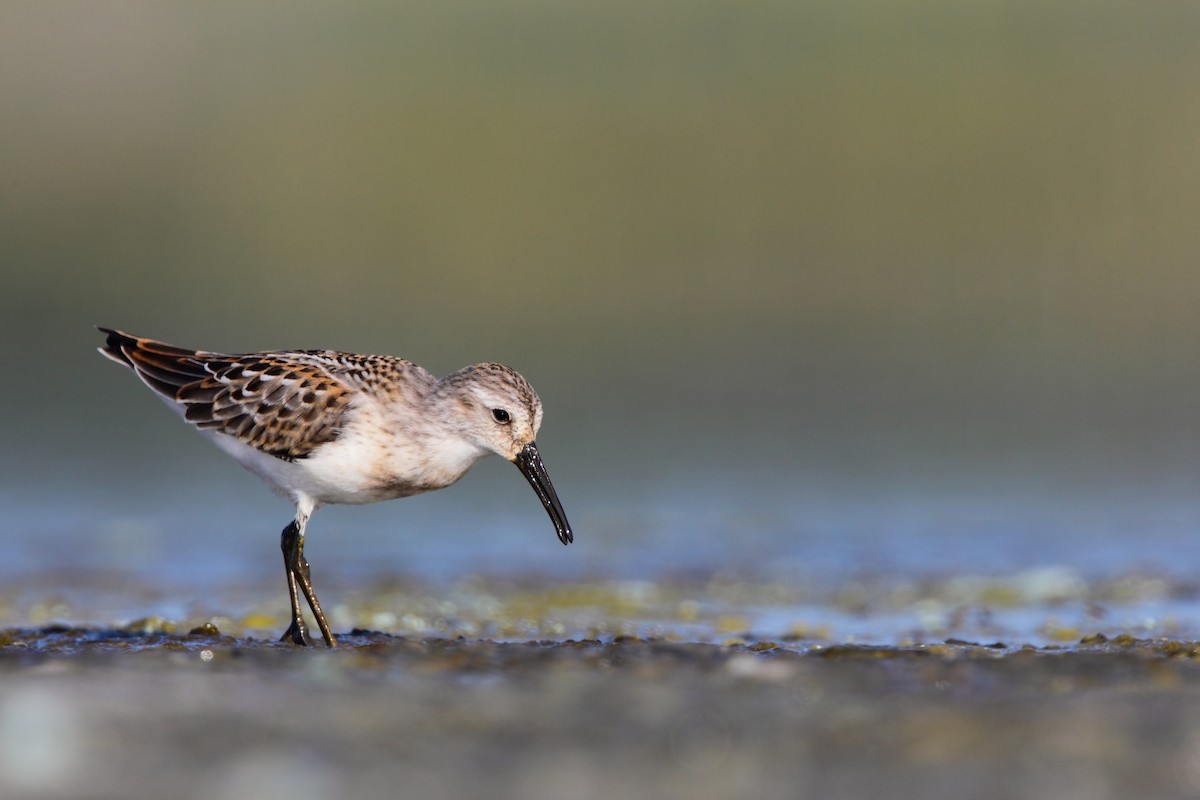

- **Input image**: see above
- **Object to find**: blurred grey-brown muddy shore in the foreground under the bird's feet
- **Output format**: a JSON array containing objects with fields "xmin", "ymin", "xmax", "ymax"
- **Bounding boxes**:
[{"xmin": 0, "ymin": 626, "xmax": 1200, "ymax": 800}]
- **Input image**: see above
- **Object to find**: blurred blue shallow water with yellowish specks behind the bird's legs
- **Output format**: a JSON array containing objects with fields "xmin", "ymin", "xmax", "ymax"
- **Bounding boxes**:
[{"xmin": 0, "ymin": 460, "xmax": 1200, "ymax": 645}]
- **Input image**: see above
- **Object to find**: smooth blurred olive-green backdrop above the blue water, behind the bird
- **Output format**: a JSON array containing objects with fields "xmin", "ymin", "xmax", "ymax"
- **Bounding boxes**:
[{"xmin": 0, "ymin": 0, "xmax": 1200, "ymax": 575}]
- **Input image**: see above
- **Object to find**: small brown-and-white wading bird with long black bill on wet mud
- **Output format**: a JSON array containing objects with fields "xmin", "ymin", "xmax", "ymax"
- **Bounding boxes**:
[{"xmin": 98, "ymin": 327, "xmax": 574, "ymax": 646}]
